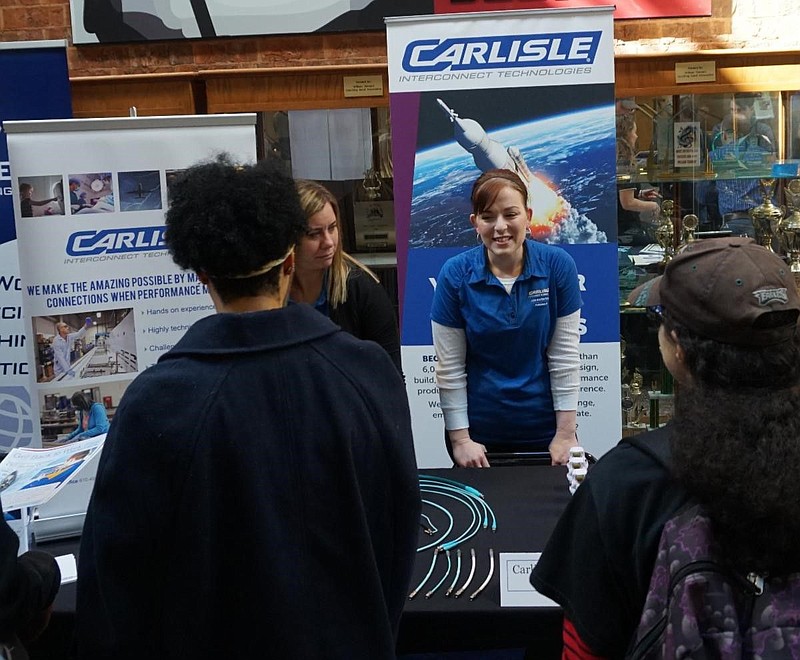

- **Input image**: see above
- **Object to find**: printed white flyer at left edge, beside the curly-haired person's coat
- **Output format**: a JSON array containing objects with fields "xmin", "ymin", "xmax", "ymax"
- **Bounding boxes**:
[{"xmin": 0, "ymin": 433, "xmax": 106, "ymax": 511}]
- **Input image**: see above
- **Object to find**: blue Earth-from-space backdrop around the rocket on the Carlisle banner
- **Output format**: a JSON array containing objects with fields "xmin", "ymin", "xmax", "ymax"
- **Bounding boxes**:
[{"xmin": 409, "ymin": 107, "xmax": 617, "ymax": 248}]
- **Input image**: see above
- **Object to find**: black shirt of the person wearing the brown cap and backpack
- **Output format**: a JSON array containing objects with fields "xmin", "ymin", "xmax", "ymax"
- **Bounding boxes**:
[{"xmin": 531, "ymin": 425, "xmax": 689, "ymax": 658}]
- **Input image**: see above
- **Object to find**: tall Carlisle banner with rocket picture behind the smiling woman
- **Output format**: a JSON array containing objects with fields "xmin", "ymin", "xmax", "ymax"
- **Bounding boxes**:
[{"xmin": 387, "ymin": 7, "xmax": 621, "ymax": 467}]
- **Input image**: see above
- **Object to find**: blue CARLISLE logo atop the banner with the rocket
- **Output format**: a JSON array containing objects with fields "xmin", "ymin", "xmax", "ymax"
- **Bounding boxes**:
[{"xmin": 403, "ymin": 31, "xmax": 602, "ymax": 73}]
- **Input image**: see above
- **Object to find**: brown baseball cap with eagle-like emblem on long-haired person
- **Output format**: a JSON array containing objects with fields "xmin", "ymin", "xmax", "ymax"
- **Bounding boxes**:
[{"xmin": 630, "ymin": 237, "xmax": 800, "ymax": 346}]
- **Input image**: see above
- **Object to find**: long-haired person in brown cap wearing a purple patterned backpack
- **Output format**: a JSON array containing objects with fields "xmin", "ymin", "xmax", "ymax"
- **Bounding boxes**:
[{"xmin": 531, "ymin": 238, "xmax": 800, "ymax": 658}]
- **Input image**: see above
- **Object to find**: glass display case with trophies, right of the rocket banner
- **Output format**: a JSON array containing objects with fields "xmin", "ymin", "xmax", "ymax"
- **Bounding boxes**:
[{"xmin": 616, "ymin": 91, "xmax": 800, "ymax": 432}]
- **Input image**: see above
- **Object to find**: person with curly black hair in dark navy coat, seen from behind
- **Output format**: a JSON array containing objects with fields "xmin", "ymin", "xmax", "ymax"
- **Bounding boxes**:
[{"xmin": 76, "ymin": 157, "xmax": 421, "ymax": 659}]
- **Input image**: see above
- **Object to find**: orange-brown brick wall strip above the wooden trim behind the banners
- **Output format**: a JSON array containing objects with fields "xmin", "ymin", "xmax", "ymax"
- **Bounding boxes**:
[{"xmin": 0, "ymin": 0, "xmax": 800, "ymax": 76}]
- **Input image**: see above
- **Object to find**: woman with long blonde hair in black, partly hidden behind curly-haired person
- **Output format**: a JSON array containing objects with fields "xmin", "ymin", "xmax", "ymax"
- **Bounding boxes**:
[{"xmin": 290, "ymin": 179, "xmax": 403, "ymax": 373}]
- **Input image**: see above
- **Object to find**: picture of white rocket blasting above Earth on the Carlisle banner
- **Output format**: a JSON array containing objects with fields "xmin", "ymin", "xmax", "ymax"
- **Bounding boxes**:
[{"xmin": 410, "ymin": 87, "xmax": 616, "ymax": 247}]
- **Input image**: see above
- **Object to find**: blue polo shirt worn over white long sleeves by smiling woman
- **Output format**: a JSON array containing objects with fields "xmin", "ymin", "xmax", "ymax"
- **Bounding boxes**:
[{"xmin": 431, "ymin": 240, "xmax": 581, "ymax": 449}]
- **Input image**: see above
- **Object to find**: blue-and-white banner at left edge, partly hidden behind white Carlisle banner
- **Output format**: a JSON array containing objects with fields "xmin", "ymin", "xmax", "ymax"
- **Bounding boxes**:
[{"xmin": 0, "ymin": 40, "xmax": 72, "ymax": 451}]
